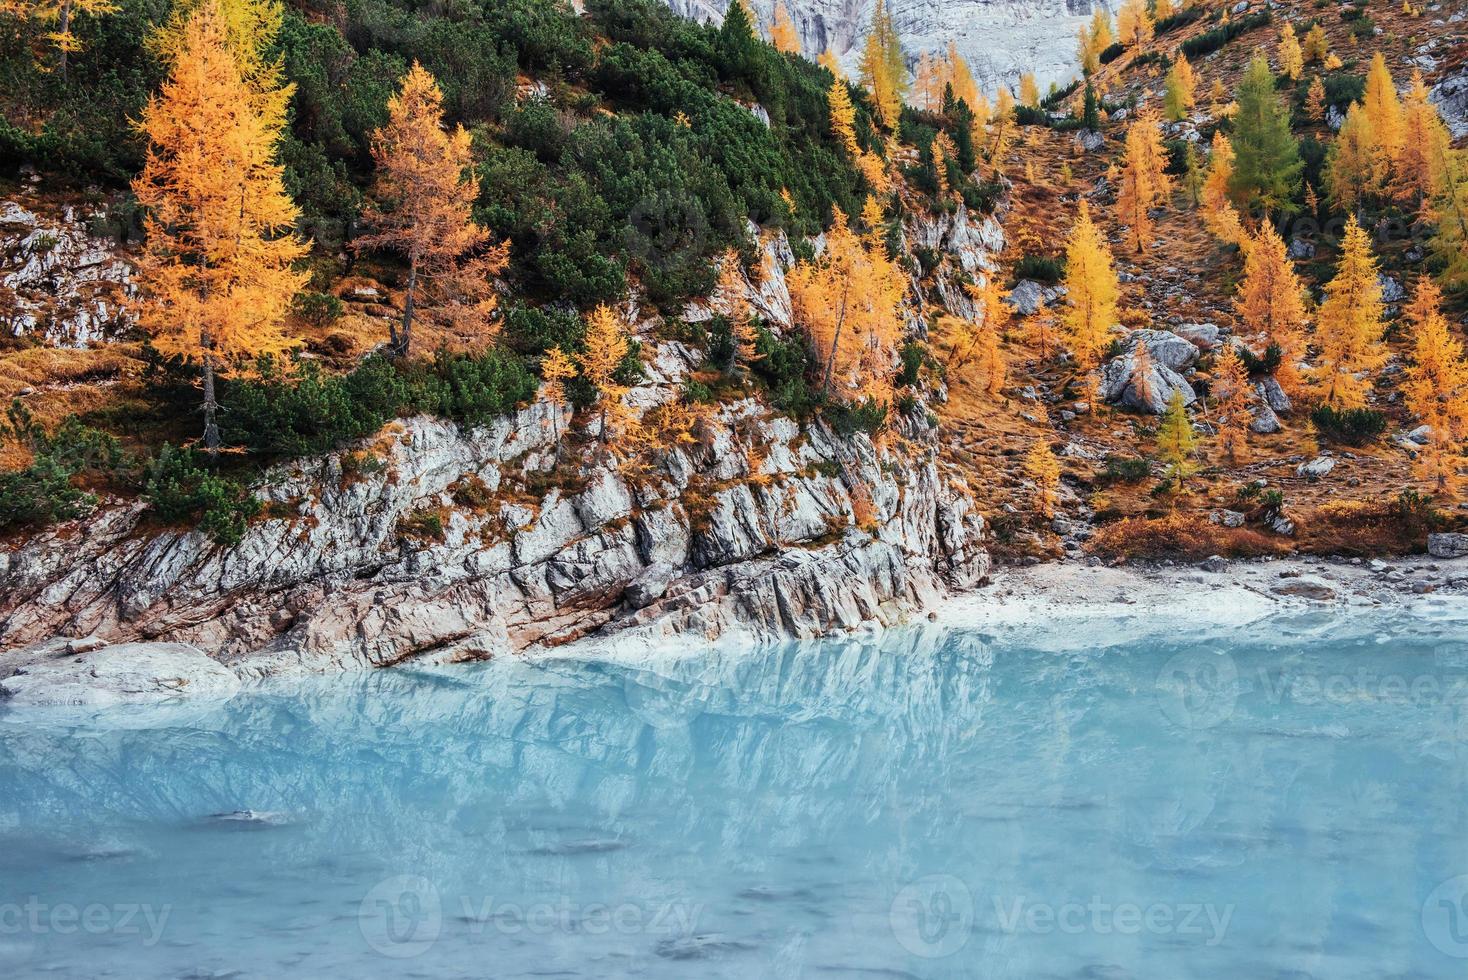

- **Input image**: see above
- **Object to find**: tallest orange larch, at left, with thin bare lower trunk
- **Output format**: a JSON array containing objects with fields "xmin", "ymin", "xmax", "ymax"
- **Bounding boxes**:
[{"xmin": 132, "ymin": 0, "xmax": 307, "ymax": 453}]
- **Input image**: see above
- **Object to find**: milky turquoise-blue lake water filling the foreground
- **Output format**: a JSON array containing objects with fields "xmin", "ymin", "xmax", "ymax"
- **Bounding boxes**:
[{"xmin": 0, "ymin": 618, "xmax": 1468, "ymax": 980}]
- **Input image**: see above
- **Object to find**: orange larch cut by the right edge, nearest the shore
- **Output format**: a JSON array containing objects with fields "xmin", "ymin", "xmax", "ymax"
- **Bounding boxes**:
[{"xmin": 1402, "ymin": 276, "xmax": 1468, "ymax": 491}]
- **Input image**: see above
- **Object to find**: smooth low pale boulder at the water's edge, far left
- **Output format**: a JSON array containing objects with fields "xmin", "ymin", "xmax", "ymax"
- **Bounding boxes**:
[{"xmin": 0, "ymin": 640, "xmax": 239, "ymax": 707}]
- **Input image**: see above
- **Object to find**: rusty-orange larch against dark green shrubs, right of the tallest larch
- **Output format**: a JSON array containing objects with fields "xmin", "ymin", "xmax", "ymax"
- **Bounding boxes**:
[{"xmin": 354, "ymin": 62, "xmax": 509, "ymax": 356}]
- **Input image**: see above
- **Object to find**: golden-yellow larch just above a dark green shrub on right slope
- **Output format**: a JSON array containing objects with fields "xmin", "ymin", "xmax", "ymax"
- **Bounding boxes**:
[{"xmin": 1314, "ymin": 214, "xmax": 1384, "ymax": 408}]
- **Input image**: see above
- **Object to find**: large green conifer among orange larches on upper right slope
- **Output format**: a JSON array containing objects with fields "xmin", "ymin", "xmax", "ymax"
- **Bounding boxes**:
[{"xmin": 1229, "ymin": 53, "xmax": 1305, "ymax": 216}]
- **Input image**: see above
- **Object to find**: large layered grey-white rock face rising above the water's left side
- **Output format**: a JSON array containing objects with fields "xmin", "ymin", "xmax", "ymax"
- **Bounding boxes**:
[{"xmin": 0, "ymin": 399, "xmax": 988, "ymax": 684}]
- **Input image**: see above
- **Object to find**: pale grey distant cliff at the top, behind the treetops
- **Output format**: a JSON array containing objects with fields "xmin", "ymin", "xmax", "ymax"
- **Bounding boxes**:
[{"xmin": 668, "ymin": 0, "xmax": 1120, "ymax": 94}]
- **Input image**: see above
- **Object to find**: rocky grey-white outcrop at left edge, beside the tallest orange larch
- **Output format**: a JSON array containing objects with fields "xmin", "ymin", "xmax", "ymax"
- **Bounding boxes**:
[{"xmin": 0, "ymin": 201, "xmax": 132, "ymax": 346}]
